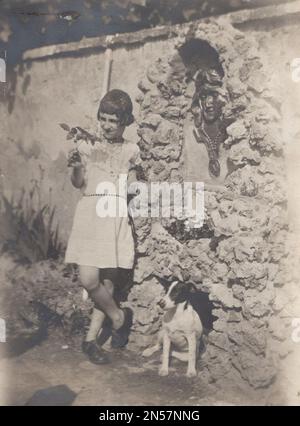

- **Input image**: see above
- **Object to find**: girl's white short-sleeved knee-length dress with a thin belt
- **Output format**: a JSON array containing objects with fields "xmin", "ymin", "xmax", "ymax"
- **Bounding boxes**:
[{"xmin": 65, "ymin": 140, "xmax": 139, "ymax": 269}]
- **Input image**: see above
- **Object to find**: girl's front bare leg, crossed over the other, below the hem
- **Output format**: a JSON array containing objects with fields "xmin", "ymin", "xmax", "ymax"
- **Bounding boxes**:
[{"xmin": 79, "ymin": 266, "xmax": 124, "ymax": 330}]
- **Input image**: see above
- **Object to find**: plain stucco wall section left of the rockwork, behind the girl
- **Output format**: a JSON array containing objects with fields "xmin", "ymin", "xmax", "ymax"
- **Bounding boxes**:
[{"xmin": 1, "ymin": 37, "xmax": 176, "ymax": 240}]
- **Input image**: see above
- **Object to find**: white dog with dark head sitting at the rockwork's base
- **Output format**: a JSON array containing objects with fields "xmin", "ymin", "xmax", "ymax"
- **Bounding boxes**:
[{"xmin": 142, "ymin": 281, "xmax": 211, "ymax": 377}]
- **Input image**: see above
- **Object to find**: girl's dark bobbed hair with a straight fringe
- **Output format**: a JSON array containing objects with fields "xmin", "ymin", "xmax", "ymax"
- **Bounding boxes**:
[{"xmin": 97, "ymin": 89, "xmax": 134, "ymax": 126}]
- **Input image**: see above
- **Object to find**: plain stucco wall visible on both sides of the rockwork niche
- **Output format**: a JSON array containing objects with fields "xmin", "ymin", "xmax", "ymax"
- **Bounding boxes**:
[{"xmin": 0, "ymin": 2, "xmax": 300, "ymax": 240}]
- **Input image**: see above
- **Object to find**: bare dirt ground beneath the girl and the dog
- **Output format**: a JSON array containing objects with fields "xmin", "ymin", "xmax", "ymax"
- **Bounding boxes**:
[{"xmin": 0, "ymin": 335, "xmax": 270, "ymax": 406}]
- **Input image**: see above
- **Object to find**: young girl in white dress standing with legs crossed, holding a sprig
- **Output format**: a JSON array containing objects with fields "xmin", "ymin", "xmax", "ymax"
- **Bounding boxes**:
[{"xmin": 65, "ymin": 90, "xmax": 138, "ymax": 364}]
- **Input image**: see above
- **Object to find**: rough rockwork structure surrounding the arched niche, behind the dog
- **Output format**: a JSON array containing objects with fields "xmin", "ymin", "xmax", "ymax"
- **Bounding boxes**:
[{"xmin": 128, "ymin": 23, "xmax": 287, "ymax": 388}]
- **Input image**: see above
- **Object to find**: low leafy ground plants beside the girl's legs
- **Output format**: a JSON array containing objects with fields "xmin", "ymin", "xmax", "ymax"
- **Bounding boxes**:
[{"xmin": 7, "ymin": 258, "xmax": 93, "ymax": 337}]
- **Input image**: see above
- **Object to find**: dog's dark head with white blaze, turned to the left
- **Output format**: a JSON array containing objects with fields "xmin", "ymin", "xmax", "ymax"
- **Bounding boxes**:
[{"xmin": 158, "ymin": 281, "xmax": 197, "ymax": 310}]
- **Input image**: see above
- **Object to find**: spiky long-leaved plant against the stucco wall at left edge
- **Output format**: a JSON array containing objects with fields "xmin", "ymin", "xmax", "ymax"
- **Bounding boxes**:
[{"xmin": 0, "ymin": 186, "xmax": 63, "ymax": 263}]
